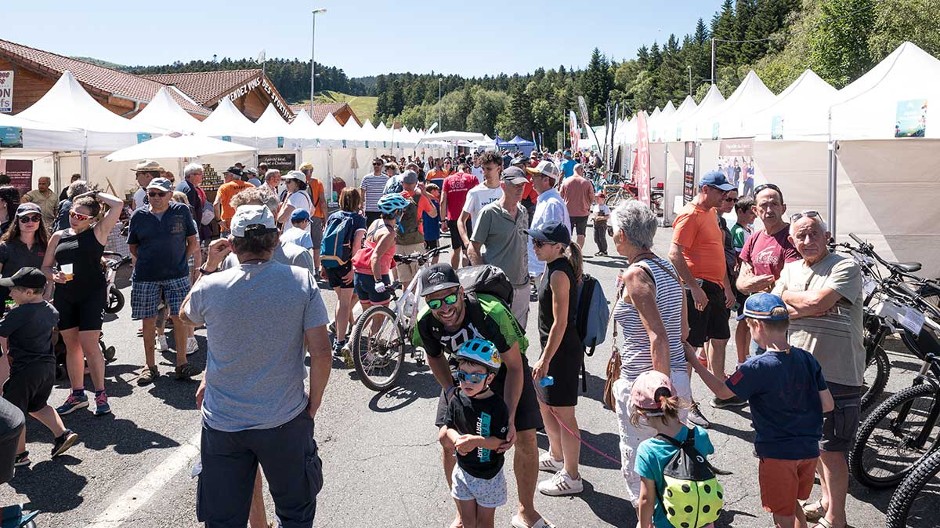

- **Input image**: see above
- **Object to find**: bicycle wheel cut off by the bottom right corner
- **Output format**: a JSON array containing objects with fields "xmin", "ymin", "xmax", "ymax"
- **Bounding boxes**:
[{"xmin": 885, "ymin": 451, "xmax": 940, "ymax": 528}]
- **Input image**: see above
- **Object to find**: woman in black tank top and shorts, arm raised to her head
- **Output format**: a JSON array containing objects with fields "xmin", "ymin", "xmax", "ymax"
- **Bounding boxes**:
[{"xmin": 42, "ymin": 191, "xmax": 124, "ymax": 416}]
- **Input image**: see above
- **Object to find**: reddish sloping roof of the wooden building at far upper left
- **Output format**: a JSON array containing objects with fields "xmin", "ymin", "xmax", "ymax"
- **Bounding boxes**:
[{"xmin": 0, "ymin": 40, "xmax": 209, "ymax": 115}]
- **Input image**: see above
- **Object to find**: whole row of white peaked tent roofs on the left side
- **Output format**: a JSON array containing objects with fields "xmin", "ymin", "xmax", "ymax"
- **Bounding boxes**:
[{"xmin": 0, "ymin": 71, "xmax": 468, "ymax": 153}]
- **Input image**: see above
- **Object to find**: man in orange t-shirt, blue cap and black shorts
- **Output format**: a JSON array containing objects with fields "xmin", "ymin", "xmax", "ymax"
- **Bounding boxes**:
[{"xmin": 669, "ymin": 171, "xmax": 740, "ymax": 418}]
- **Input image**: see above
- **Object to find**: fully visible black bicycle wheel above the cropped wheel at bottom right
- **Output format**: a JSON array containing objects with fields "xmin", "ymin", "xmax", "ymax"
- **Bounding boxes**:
[{"xmin": 849, "ymin": 383, "xmax": 940, "ymax": 488}]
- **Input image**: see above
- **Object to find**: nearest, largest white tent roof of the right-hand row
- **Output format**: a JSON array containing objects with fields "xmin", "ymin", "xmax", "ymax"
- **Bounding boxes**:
[{"xmin": 831, "ymin": 42, "xmax": 940, "ymax": 140}]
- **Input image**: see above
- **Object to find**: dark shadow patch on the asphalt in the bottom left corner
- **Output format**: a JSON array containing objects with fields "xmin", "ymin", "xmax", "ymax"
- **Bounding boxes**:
[{"xmin": 9, "ymin": 455, "xmax": 88, "ymax": 512}]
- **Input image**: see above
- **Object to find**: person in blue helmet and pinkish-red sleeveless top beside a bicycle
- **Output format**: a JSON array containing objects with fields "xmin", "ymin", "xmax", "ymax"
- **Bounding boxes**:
[{"xmin": 352, "ymin": 193, "xmax": 411, "ymax": 310}]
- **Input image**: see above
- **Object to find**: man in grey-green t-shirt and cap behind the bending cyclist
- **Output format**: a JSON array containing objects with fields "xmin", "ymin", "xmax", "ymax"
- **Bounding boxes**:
[{"xmin": 468, "ymin": 167, "xmax": 529, "ymax": 328}]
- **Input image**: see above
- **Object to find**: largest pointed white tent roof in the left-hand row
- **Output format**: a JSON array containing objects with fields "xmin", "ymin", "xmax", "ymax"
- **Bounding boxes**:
[{"xmin": 17, "ymin": 71, "xmax": 141, "ymax": 152}]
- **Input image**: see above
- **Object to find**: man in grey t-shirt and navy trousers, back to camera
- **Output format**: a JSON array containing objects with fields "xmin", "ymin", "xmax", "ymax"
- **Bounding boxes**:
[{"xmin": 181, "ymin": 205, "xmax": 331, "ymax": 527}]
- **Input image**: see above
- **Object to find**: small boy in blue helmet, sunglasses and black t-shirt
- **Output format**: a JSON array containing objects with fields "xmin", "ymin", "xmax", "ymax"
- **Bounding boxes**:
[{"xmin": 431, "ymin": 338, "xmax": 509, "ymax": 528}]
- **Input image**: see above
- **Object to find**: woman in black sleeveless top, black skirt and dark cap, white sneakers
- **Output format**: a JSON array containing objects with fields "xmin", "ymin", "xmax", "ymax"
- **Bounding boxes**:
[{"xmin": 528, "ymin": 222, "xmax": 584, "ymax": 495}]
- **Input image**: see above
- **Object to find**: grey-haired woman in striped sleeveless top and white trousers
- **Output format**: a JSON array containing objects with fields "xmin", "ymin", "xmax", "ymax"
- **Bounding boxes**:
[{"xmin": 612, "ymin": 200, "xmax": 691, "ymax": 507}]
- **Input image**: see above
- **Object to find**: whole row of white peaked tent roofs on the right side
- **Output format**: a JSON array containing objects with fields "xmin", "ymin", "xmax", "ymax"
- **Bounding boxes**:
[{"xmin": 601, "ymin": 42, "xmax": 940, "ymax": 144}]
